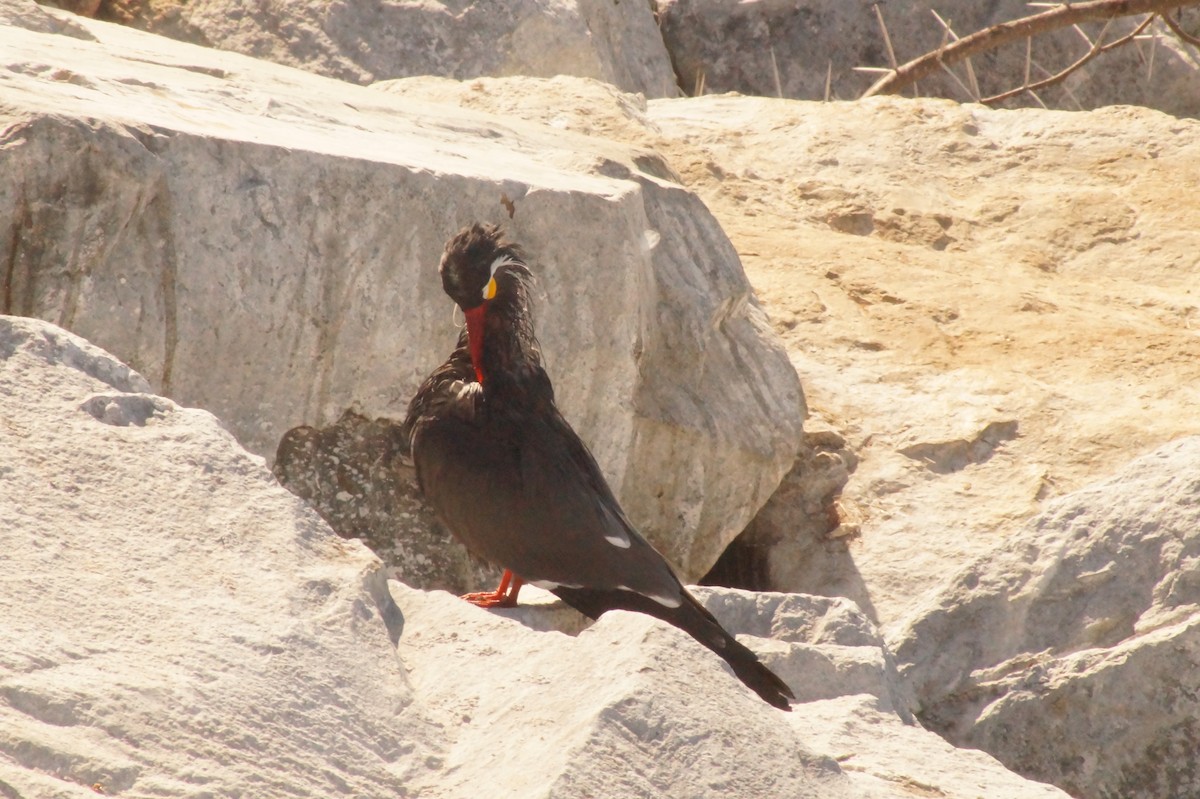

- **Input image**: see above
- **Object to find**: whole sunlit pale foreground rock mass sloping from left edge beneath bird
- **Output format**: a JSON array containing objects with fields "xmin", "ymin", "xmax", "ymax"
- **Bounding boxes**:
[{"xmin": 0, "ymin": 317, "xmax": 1066, "ymax": 799}]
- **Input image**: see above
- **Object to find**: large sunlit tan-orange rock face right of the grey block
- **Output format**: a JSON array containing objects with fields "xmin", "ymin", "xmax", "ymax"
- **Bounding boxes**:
[{"xmin": 649, "ymin": 91, "xmax": 1200, "ymax": 639}]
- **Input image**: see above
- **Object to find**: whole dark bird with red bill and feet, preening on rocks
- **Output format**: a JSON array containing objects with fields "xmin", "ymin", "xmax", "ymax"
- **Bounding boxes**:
[{"xmin": 404, "ymin": 224, "xmax": 794, "ymax": 710}]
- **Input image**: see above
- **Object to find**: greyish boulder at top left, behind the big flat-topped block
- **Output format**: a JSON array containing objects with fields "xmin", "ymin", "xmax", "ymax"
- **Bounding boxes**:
[{"xmin": 65, "ymin": 0, "xmax": 679, "ymax": 97}]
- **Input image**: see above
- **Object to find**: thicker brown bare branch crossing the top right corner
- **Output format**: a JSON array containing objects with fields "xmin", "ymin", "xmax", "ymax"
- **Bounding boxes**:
[{"xmin": 863, "ymin": 0, "xmax": 1200, "ymax": 97}]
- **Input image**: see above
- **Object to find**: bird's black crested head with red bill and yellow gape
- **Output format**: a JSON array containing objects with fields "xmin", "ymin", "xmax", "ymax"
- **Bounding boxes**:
[{"xmin": 438, "ymin": 222, "xmax": 529, "ymax": 383}]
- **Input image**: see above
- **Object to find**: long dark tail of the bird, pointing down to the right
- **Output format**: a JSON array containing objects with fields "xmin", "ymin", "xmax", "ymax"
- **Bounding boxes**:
[{"xmin": 554, "ymin": 588, "xmax": 796, "ymax": 710}]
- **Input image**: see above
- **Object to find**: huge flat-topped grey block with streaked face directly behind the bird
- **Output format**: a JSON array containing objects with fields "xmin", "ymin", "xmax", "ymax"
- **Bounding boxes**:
[{"xmin": 0, "ymin": 6, "xmax": 803, "ymax": 579}]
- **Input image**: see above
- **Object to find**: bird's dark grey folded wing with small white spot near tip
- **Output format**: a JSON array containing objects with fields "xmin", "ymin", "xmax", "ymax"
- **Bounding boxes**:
[{"xmin": 413, "ymin": 386, "xmax": 683, "ymax": 607}]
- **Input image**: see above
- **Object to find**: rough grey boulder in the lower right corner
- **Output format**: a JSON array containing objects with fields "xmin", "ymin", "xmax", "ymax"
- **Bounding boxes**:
[{"xmin": 896, "ymin": 437, "xmax": 1200, "ymax": 799}]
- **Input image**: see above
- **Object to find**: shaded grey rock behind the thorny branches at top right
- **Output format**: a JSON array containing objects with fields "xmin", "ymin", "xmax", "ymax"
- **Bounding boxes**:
[{"xmin": 658, "ymin": 0, "xmax": 1200, "ymax": 116}]
